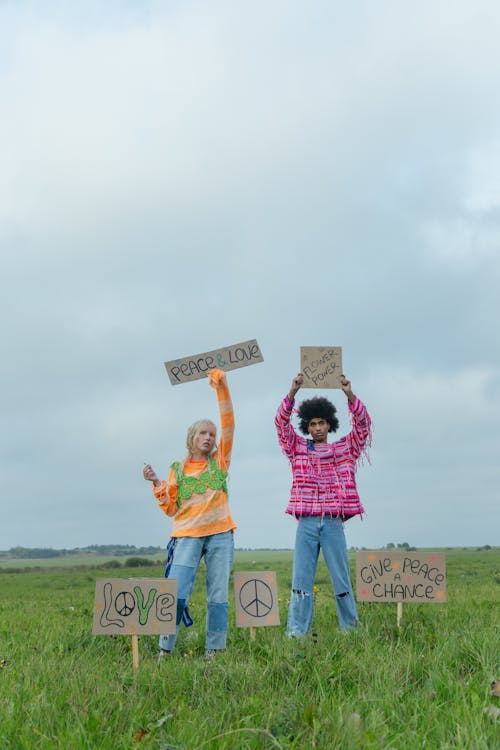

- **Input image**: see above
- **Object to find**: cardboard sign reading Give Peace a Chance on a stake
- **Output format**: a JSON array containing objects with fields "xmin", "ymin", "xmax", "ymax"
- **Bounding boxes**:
[{"xmin": 356, "ymin": 550, "xmax": 446, "ymax": 604}]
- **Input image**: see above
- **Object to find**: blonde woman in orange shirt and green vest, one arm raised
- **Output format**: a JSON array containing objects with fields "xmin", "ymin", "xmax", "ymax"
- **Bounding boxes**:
[{"xmin": 144, "ymin": 370, "xmax": 236, "ymax": 657}]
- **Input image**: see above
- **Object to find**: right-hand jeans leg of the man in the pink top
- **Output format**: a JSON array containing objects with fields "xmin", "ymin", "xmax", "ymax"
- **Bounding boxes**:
[{"xmin": 320, "ymin": 516, "xmax": 358, "ymax": 630}]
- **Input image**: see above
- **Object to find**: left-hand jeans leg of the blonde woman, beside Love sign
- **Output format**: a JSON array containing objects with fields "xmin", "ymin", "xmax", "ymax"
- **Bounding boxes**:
[{"xmin": 160, "ymin": 537, "xmax": 204, "ymax": 651}]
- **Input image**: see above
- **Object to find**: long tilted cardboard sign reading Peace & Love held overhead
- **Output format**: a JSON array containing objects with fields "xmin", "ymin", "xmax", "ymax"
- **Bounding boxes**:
[{"xmin": 164, "ymin": 339, "xmax": 264, "ymax": 385}]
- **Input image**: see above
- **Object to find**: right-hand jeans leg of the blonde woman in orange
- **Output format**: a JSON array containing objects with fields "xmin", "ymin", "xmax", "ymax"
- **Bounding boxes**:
[{"xmin": 204, "ymin": 531, "xmax": 234, "ymax": 650}]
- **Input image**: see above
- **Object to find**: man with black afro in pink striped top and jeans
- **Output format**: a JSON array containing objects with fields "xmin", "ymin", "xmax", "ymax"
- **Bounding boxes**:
[{"xmin": 275, "ymin": 373, "xmax": 371, "ymax": 638}]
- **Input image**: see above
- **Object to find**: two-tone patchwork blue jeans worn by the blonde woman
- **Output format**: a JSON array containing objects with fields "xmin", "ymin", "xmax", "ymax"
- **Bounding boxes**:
[{"xmin": 160, "ymin": 531, "xmax": 234, "ymax": 651}]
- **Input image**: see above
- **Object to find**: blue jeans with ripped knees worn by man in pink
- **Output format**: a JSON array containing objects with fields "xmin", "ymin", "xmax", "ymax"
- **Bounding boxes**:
[{"xmin": 288, "ymin": 516, "xmax": 358, "ymax": 637}]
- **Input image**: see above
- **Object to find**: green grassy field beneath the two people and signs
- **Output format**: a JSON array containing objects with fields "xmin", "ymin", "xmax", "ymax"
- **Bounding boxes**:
[{"xmin": 0, "ymin": 549, "xmax": 500, "ymax": 750}]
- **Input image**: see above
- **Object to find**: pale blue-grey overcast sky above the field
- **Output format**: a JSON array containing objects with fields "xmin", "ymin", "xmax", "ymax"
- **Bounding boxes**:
[{"xmin": 0, "ymin": 0, "xmax": 500, "ymax": 549}]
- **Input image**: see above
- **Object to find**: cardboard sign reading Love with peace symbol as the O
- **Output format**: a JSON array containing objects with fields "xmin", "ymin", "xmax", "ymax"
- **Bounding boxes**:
[{"xmin": 92, "ymin": 578, "xmax": 177, "ymax": 635}]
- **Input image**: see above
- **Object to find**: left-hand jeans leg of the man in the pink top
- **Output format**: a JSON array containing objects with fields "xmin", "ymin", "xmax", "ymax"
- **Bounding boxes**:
[{"xmin": 287, "ymin": 516, "xmax": 320, "ymax": 637}]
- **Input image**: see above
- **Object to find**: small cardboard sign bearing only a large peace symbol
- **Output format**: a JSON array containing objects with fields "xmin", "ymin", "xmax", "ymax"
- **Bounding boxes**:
[{"xmin": 234, "ymin": 570, "xmax": 280, "ymax": 628}]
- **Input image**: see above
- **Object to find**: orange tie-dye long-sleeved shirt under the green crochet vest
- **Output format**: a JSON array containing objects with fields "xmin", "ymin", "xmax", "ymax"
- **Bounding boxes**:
[{"xmin": 152, "ymin": 370, "xmax": 236, "ymax": 537}]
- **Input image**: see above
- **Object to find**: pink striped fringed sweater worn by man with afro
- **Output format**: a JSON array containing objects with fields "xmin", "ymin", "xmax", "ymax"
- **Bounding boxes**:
[{"xmin": 274, "ymin": 396, "xmax": 371, "ymax": 519}]
